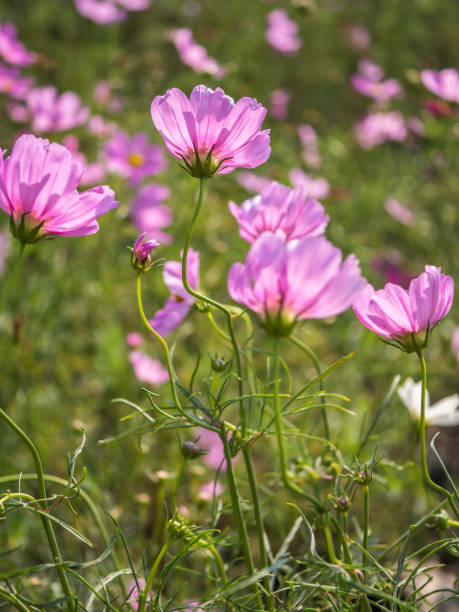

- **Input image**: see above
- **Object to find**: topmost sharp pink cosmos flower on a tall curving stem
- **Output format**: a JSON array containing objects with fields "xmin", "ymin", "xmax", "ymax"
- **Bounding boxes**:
[{"xmin": 151, "ymin": 85, "xmax": 271, "ymax": 177}]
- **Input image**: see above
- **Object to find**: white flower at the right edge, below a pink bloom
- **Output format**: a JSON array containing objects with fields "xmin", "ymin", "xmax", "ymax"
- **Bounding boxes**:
[{"xmin": 397, "ymin": 378, "xmax": 459, "ymax": 427}]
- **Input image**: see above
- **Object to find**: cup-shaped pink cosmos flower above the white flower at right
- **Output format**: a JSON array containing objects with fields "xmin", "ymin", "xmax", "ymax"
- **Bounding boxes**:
[{"xmin": 352, "ymin": 266, "xmax": 454, "ymax": 352}]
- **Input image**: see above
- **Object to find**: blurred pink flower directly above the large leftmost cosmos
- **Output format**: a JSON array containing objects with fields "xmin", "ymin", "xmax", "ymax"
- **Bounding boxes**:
[{"xmin": 26, "ymin": 86, "xmax": 89, "ymax": 133}]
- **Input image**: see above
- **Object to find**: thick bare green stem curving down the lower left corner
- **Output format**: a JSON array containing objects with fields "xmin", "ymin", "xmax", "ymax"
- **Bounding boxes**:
[{"xmin": 0, "ymin": 408, "xmax": 76, "ymax": 612}]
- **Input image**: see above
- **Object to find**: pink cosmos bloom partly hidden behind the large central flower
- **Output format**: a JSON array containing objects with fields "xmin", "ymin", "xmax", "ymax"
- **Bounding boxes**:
[{"xmin": 229, "ymin": 181, "xmax": 329, "ymax": 242}]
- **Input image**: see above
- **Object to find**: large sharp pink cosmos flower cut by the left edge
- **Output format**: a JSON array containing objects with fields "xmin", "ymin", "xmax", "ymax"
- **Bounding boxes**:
[{"xmin": 0, "ymin": 134, "xmax": 118, "ymax": 243}]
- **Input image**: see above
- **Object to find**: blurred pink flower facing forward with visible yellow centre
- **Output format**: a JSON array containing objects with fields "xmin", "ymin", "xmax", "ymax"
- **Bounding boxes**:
[{"xmin": 104, "ymin": 132, "xmax": 167, "ymax": 185}]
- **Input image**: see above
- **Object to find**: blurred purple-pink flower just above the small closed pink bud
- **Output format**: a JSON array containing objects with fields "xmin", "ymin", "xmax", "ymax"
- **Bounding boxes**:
[{"xmin": 131, "ymin": 183, "xmax": 172, "ymax": 244}]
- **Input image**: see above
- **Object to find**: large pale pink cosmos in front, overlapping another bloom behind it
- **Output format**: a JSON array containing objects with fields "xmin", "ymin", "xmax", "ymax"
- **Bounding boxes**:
[{"xmin": 228, "ymin": 232, "xmax": 365, "ymax": 335}]
